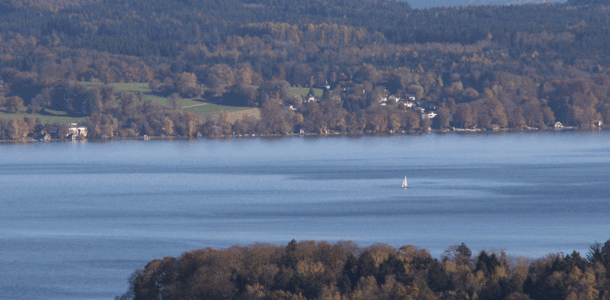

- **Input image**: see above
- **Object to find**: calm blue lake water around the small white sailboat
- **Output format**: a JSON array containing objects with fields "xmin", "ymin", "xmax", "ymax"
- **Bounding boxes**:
[{"xmin": 0, "ymin": 132, "xmax": 610, "ymax": 299}]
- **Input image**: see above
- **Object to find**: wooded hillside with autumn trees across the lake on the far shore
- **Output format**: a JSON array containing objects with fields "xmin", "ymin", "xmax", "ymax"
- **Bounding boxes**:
[{"xmin": 0, "ymin": 0, "xmax": 610, "ymax": 140}]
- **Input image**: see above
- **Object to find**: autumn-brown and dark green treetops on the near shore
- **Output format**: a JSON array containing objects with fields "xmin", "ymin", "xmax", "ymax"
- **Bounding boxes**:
[{"xmin": 116, "ymin": 240, "xmax": 610, "ymax": 300}]
